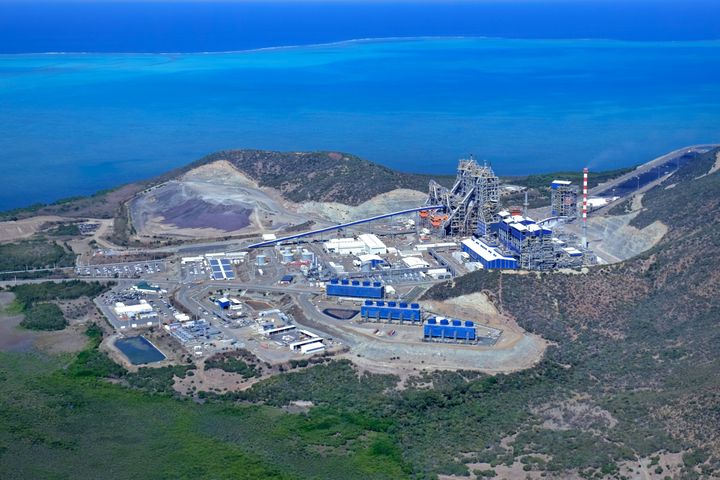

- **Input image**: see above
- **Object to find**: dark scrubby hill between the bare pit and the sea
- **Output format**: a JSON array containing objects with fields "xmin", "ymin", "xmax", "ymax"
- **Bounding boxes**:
[{"xmin": 197, "ymin": 150, "xmax": 444, "ymax": 206}]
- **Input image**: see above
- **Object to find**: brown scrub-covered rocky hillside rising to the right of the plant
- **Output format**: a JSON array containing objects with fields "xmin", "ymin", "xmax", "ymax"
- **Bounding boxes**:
[{"xmin": 426, "ymin": 146, "xmax": 720, "ymax": 478}]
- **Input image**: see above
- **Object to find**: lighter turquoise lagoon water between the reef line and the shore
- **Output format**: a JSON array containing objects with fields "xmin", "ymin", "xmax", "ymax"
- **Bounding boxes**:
[{"xmin": 0, "ymin": 38, "xmax": 720, "ymax": 208}]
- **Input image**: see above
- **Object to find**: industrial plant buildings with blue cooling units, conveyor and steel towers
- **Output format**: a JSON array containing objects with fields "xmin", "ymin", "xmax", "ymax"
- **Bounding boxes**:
[{"xmin": 91, "ymin": 158, "xmax": 595, "ymax": 372}]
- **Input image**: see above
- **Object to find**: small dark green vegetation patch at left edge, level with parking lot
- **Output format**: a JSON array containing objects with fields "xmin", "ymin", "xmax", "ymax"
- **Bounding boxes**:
[{"xmin": 0, "ymin": 240, "xmax": 75, "ymax": 271}]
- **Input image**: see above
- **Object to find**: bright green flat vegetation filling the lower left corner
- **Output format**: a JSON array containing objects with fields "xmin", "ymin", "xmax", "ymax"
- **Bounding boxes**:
[{"xmin": 0, "ymin": 327, "xmax": 407, "ymax": 480}]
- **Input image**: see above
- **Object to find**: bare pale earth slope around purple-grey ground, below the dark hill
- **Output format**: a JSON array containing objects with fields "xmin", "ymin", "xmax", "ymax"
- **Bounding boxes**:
[{"xmin": 129, "ymin": 160, "xmax": 425, "ymax": 238}]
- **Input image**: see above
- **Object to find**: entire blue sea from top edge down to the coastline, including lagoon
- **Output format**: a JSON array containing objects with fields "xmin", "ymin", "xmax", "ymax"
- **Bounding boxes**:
[{"xmin": 0, "ymin": 0, "xmax": 720, "ymax": 209}]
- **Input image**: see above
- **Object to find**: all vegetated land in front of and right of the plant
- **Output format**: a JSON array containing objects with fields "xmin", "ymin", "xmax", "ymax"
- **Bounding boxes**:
[{"xmin": 0, "ymin": 151, "xmax": 720, "ymax": 479}]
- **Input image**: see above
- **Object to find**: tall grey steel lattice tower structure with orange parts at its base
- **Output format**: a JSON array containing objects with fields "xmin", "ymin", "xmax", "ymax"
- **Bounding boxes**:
[{"xmin": 421, "ymin": 158, "xmax": 500, "ymax": 236}]
